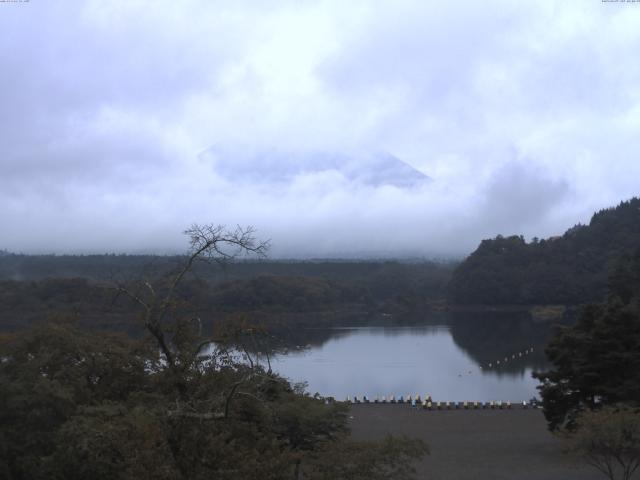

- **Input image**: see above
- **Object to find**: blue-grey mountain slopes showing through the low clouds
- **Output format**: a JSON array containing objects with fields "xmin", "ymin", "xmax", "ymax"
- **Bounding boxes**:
[{"xmin": 200, "ymin": 146, "xmax": 431, "ymax": 188}]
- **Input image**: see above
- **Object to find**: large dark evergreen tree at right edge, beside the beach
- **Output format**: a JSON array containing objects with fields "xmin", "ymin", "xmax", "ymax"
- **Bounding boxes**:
[{"xmin": 534, "ymin": 249, "xmax": 640, "ymax": 430}]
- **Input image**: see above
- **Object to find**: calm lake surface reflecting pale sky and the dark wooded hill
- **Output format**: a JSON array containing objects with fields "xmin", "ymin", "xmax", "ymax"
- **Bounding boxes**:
[{"xmin": 272, "ymin": 314, "xmax": 549, "ymax": 402}]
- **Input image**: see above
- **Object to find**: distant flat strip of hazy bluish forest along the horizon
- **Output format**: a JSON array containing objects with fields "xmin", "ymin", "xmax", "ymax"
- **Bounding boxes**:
[{"xmin": 0, "ymin": 250, "xmax": 457, "ymax": 299}]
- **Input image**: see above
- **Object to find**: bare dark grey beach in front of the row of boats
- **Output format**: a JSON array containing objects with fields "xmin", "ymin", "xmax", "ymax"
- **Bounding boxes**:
[{"xmin": 351, "ymin": 404, "xmax": 605, "ymax": 480}]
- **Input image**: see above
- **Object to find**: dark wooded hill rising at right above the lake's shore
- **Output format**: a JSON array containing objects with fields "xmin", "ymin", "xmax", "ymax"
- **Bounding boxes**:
[{"xmin": 449, "ymin": 198, "xmax": 640, "ymax": 305}]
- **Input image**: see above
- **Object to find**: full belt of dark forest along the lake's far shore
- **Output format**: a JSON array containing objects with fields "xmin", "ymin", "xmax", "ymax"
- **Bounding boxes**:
[{"xmin": 0, "ymin": 253, "xmax": 454, "ymax": 335}]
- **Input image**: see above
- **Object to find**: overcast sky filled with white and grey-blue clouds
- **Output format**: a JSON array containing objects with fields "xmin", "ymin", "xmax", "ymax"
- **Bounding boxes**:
[{"xmin": 0, "ymin": 0, "xmax": 640, "ymax": 258}]
